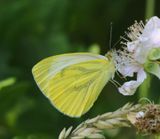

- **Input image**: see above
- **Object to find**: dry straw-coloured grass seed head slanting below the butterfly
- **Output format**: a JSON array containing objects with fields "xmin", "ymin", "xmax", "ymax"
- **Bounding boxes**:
[{"xmin": 59, "ymin": 103, "xmax": 141, "ymax": 139}]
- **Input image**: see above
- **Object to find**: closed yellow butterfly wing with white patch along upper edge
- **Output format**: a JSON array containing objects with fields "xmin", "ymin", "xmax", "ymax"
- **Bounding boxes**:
[{"xmin": 32, "ymin": 53, "xmax": 115, "ymax": 117}]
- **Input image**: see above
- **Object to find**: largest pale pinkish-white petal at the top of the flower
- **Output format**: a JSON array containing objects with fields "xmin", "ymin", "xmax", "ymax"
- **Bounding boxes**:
[{"xmin": 127, "ymin": 16, "xmax": 160, "ymax": 64}]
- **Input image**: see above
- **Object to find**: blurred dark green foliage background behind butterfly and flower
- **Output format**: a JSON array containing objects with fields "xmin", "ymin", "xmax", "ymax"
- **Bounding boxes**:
[{"xmin": 0, "ymin": 0, "xmax": 160, "ymax": 139}]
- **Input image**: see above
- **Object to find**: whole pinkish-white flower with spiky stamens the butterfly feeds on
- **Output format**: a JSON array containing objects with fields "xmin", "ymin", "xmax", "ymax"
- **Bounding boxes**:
[{"xmin": 114, "ymin": 16, "xmax": 160, "ymax": 95}]
